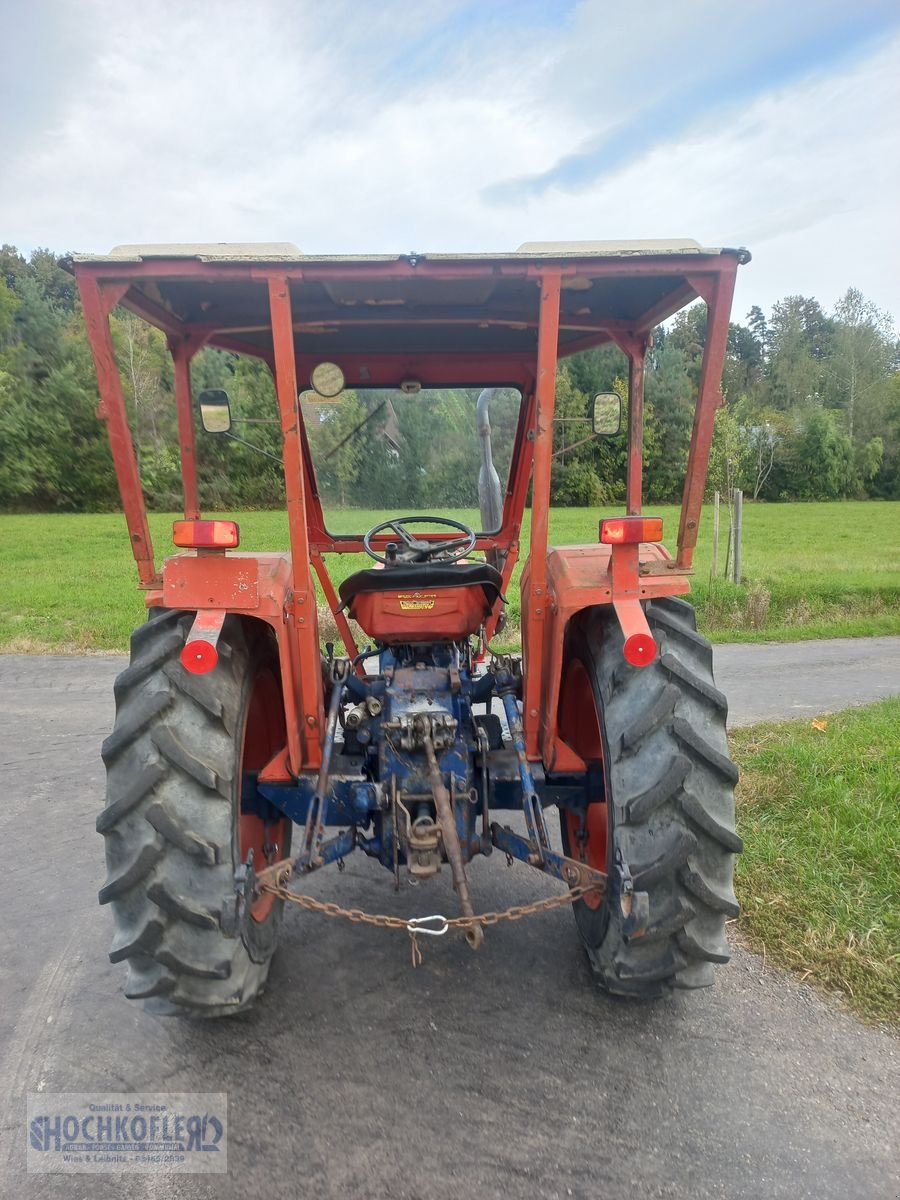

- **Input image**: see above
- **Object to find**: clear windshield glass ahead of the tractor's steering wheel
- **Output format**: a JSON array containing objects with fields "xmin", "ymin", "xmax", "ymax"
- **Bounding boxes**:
[{"xmin": 300, "ymin": 388, "xmax": 522, "ymax": 534}]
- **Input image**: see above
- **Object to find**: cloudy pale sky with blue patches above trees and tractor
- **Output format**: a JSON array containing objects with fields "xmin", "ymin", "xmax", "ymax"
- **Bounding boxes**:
[{"xmin": 0, "ymin": 0, "xmax": 900, "ymax": 318}]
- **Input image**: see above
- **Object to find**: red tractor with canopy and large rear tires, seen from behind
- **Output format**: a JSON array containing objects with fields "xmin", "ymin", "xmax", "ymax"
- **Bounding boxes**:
[{"xmin": 74, "ymin": 241, "xmax": 749, "ymax": 1015}]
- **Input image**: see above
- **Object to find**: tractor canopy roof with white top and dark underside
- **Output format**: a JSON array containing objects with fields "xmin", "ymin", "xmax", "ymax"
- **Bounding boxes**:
[{"xmin": 73, "ymin": 239, "xmax": 750, "ymax": 364}]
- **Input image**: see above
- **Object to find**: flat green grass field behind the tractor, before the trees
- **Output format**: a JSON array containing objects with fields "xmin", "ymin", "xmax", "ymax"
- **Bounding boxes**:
[{"xmin": 0, "ymin": 502, "xmax": 900, "ymax": 653}]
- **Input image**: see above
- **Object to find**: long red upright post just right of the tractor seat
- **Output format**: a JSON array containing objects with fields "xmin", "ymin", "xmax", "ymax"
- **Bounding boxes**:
[{"xmin": 523, "ymin": 270, "xmax": 560, "ymax": 758}]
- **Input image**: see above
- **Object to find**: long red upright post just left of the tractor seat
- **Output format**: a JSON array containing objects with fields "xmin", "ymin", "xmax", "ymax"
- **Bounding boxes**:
[{"xmin": 269, "ymin": 276, "xmax": 322, "ymax": 767}]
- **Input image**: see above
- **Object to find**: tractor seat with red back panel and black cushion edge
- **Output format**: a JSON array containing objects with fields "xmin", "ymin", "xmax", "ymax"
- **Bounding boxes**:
[{"xmin": 338, "ymin": 563, "xmax": 503, "ymax": 646}]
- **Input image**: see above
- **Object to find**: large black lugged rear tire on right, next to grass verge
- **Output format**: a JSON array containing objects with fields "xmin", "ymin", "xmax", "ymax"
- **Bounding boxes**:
[{"xmin": 560, "ymin": 598, "xmax": 742, "ymax": 998}]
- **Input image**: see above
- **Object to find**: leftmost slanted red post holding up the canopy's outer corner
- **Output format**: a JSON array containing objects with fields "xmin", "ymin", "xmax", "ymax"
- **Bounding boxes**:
[{"xmin": 78, "ymin": 275, "xmax": 158, "ymax": 587}]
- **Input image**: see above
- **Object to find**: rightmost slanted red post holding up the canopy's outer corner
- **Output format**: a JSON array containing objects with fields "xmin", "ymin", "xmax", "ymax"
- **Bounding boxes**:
[{"xmin": 677, "ymin": 258, "xmax": 738, "ymax": 570}]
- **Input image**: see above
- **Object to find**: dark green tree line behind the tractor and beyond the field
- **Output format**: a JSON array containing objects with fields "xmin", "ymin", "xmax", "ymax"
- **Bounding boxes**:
[{"xmin": 0, "ymin": 246, "xmax": 900, "ymax": 511}]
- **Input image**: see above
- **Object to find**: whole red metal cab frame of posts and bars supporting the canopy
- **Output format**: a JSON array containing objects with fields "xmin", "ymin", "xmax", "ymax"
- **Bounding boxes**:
[{"xmin": 74, "ymin": 251, "xmax": 749, "ymax": 763}]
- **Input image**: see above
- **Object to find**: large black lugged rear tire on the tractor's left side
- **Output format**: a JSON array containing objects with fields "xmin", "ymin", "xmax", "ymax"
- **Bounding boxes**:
[{"xmin": 97, "ymin": 608, "xmax": 290, "ymax": 1016}]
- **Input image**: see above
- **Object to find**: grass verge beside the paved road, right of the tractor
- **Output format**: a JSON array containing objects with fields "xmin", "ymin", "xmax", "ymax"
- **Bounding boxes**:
[{"xmin": 731, "ymin": 698, "xmax": 900, "ymax": 1024}]
